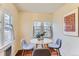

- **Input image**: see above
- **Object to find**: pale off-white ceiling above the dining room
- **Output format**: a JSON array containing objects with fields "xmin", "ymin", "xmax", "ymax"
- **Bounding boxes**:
[{"xmin": 15, "ymin": 3, "xmax": 64, "ymax": 13}]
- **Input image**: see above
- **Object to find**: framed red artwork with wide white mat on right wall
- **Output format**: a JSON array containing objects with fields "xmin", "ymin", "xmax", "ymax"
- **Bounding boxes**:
[{"xmin": 63, "ymin": 8, "xmax": 79, "ymax": 36}]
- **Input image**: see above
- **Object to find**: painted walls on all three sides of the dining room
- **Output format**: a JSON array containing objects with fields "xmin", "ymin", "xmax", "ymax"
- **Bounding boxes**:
[{"xmin": 0, "ymin": 4, "xmax": 79, "ymax": 55}]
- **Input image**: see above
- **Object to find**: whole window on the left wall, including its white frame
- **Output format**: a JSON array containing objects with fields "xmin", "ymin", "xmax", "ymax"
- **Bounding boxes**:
[{"xmin": 0, "ymin": 12, "xmax": 13, "ymax": 46}]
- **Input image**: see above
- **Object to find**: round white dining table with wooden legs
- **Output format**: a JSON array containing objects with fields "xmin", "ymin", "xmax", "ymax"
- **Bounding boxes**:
[{"xmin": 31, "ymin": 38, "xmax": 52, "ymax": 48}]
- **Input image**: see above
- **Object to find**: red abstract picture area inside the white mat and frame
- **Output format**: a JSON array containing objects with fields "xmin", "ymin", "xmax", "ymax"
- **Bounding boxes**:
[{"xmin": 64, "ymin": 13, "xmax": 75, "ymax": 32}]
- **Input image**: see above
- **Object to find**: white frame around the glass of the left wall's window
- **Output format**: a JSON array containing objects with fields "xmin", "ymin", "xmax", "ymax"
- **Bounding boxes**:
[{"xmin": 1, "ymin": 10, "xmax": 13, "ymax": 45}]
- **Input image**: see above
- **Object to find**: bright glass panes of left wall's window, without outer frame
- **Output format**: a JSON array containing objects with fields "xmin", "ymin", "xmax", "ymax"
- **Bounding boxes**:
[{"xmin": 3, "ymin": 14, "xmax": 12, "ymax": 43}]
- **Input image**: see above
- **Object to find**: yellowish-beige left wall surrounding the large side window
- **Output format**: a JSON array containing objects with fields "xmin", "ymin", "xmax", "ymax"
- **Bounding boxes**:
[{"xmin": 0, "ymin": 4, "xmax": 19, "ymax": 55}]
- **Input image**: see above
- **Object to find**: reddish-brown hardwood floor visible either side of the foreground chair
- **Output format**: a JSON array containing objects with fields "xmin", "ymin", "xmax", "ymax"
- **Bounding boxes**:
[{"xmin": 15, "ymin": 48, "xmax": 58, "ymax": 56}]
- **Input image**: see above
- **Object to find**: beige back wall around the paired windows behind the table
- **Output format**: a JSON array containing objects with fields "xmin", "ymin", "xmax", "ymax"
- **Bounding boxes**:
[{"xmin": 19, "ymin": 12, "xmax": 52, "ymax": 43}]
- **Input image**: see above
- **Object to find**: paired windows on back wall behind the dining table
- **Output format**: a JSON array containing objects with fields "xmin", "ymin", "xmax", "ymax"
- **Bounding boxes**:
[{"xmin": 33, "ymin": 21, "xmax": 52, "ymax": 38}]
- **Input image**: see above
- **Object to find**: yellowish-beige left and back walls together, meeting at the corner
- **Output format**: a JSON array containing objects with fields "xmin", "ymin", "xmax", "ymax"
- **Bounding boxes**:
[{"xmin": 0, "ymin": 4, "xmax": 52, "ymax": 55}]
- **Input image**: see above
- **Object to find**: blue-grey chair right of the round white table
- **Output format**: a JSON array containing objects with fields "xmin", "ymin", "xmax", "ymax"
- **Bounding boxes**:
[{"xmin": 48, "ymin": 39, "xmax": 62, "ymax": 55}]
